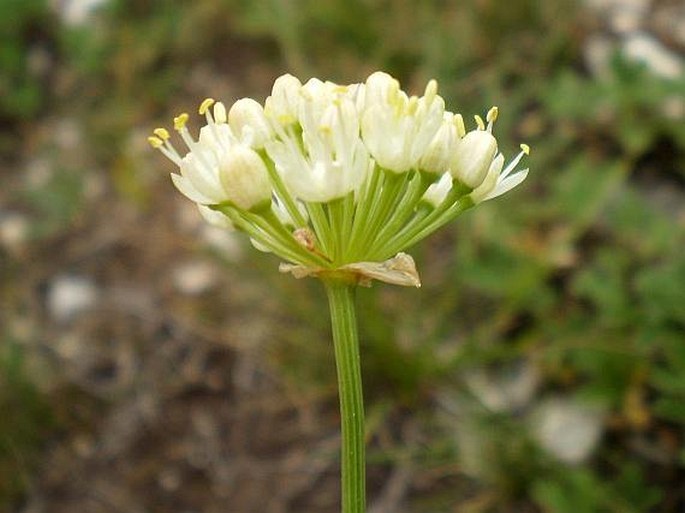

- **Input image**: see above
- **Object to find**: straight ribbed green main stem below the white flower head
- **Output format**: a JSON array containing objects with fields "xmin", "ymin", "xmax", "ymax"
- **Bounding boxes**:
[{"xmin": 324, "ymin": 277, "xmax": 366, "ymax": 513}]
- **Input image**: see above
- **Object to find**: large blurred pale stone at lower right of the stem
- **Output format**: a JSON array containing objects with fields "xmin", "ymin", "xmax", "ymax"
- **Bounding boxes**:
[{"xmin": 531, "ymin": 397, "xmax": 605, "ymax": 465}]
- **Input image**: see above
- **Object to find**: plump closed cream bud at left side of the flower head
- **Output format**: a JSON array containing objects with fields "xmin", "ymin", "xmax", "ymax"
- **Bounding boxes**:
[{"xmin": 219, "ymin": 145, "xmax": 271, "ymax": 210}]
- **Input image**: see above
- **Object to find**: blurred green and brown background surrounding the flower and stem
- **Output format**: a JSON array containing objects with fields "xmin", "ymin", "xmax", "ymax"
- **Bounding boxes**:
[{"xmin": 0, "ymin": 0, "xmax": 685, "ymax": 513}]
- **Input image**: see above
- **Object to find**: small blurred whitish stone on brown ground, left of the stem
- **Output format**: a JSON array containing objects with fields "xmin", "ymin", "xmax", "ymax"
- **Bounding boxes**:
[{"xmin": 47, "ymin": 275, "xmax": 100, "ymax": 322}]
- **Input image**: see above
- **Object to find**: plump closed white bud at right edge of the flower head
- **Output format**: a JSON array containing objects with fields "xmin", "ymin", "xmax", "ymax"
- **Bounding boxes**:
[{"xmin": 450, "ymin": 130, "xmax": 497, "ymax": 189}]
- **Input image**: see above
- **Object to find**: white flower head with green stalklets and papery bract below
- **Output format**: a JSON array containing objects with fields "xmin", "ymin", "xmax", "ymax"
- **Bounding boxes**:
[{"xmin": 149, "ymin": 72, "xmax": 529, "ymax": 286}]
